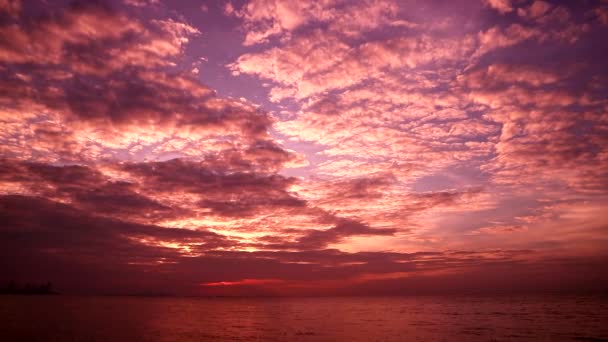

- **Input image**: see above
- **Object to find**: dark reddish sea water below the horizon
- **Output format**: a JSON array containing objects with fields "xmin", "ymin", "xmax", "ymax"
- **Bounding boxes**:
[{"xmin": 0, "ymin": 296, "xmax": 608, "ymax": 341}]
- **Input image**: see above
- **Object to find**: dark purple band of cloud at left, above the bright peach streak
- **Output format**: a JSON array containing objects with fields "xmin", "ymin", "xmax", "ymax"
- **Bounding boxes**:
[{"xmin": 0, "ymin": 67, "xmax": 274, "ymax": 138}]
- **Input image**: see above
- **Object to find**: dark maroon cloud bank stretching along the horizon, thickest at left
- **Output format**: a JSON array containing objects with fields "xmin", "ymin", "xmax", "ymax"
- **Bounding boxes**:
[{"xmin": 0, "ymin": 196, "xmax": 602, "ymax": 295}]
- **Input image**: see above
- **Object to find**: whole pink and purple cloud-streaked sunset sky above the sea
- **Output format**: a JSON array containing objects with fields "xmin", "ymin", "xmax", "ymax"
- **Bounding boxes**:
[{"xmin": 0, "ymin": 0, "xmax": 608, "ymax": 296}]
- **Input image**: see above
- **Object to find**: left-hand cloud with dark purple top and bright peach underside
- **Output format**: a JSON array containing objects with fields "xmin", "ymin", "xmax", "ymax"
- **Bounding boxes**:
[{"xmin": 0, "ymin": 71, "xmax": 280, "ymax": 163}]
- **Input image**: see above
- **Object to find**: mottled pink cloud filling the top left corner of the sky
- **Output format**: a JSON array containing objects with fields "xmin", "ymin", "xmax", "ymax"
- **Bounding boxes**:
[{"xmin": 0, "ymin": 4, "xmax": 199, "ymax": 74}]
